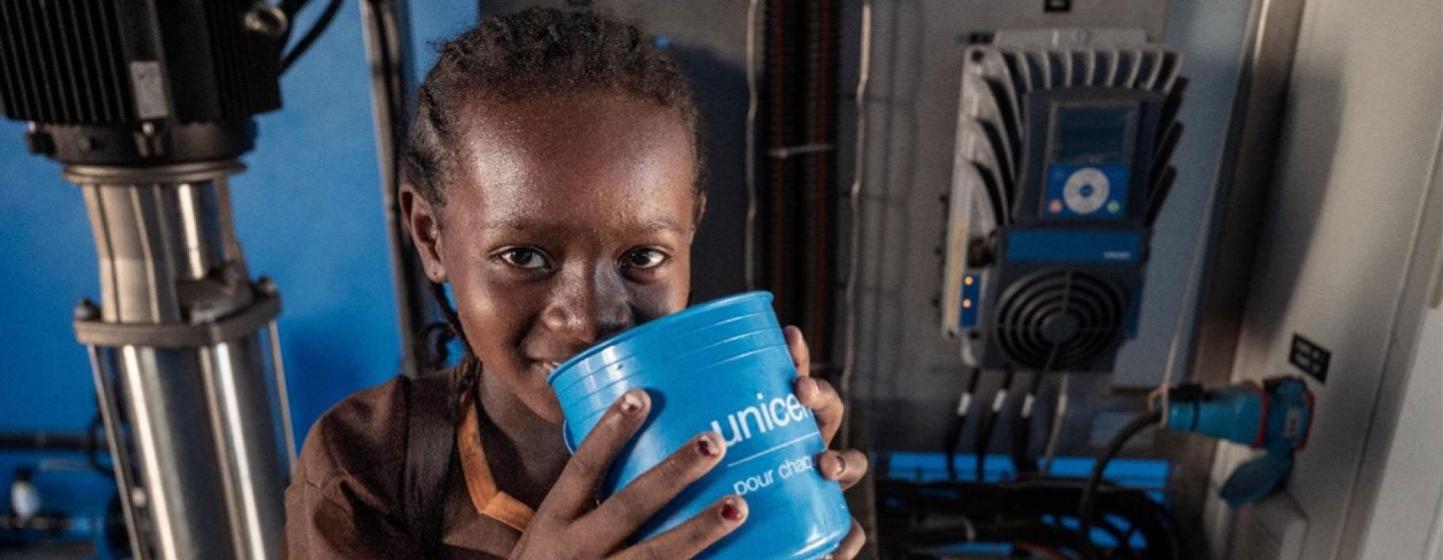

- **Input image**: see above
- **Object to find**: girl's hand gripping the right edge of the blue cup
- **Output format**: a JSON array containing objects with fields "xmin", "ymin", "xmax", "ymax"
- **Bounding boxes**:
[{"xmin": 785, "ymin": 326, "xmax": 867, "ymax": 559}]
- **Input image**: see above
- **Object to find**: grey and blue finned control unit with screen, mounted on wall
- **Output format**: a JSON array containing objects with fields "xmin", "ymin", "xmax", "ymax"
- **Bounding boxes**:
[{"xmin": 942, "ymin": 45, "xmax": 1185, "ymax": 371}]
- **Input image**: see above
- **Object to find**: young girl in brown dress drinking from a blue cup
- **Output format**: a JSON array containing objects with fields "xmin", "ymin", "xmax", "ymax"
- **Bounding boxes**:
[{"xmin": 286, "ymin": 9, "xmax": 867, "ymax": 559}]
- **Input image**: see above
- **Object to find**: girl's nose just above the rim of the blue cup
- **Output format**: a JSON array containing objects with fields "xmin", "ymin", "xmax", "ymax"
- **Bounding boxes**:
[{"xmin": 541, "ymin": 266, "xmax": 635, "ymax": 345}]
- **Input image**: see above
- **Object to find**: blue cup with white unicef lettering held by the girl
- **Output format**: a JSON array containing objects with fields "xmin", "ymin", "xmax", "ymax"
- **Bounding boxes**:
[{"xmin": 547, "ymin": 292, "xmax": 851, "ymax": 560}]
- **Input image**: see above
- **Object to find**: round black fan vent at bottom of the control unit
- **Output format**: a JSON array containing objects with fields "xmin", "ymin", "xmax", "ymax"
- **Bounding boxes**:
[{"xmin": 996, "ymin": 268, "xmax": 1128, "ymax": 371}]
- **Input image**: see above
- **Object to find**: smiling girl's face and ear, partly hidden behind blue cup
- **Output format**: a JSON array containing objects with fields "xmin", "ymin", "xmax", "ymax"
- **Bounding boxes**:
[{"xmin": 403, "ymin": 91, "xmax": 700, "ymax": 423}]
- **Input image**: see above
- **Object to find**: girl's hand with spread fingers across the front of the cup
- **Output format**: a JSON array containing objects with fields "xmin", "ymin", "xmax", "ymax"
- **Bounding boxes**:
[{"xmin": 511, "ymin": 390, "xmax": 747, "ymax": 560}]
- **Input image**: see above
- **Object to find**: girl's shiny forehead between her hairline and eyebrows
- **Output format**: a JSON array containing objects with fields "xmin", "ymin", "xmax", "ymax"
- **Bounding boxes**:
[{"xmin": 447, "ymin": 94, "xmax": 697, "ymax": 228}]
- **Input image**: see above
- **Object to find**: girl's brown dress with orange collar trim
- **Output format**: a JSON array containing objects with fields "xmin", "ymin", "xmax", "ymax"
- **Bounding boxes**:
[{"xmin": 283, "ymin": 378, "xmax": 532, "ymax": 560}]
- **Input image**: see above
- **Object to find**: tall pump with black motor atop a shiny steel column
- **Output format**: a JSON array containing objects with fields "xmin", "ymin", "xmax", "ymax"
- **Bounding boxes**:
[{"xmin": 0, "ymin": 0, "xmax": 294, "ymax": 559}]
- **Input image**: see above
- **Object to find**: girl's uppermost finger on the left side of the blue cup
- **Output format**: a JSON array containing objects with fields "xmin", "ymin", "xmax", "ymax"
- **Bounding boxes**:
[{"xmin": 537, "ymin": 390, "xmax": 651, "ymax": 520}]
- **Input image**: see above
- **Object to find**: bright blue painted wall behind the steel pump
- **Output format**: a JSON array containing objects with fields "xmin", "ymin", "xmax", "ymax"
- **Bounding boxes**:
[{"xmin": 0, "ymin": 0, "xmax": 476, "ymax": 447}]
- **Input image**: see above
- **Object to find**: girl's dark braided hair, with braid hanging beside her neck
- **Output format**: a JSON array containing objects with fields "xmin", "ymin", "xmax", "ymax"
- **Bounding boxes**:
[{"xmin": 401, "ymin": 7, "xmax": 706, "ymax": 417}]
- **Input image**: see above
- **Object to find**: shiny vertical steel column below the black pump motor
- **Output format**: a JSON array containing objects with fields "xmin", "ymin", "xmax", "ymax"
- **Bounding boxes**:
[{"xmin": 65, "ymin": 162, "xmax": 294, "ymax": 559}]
